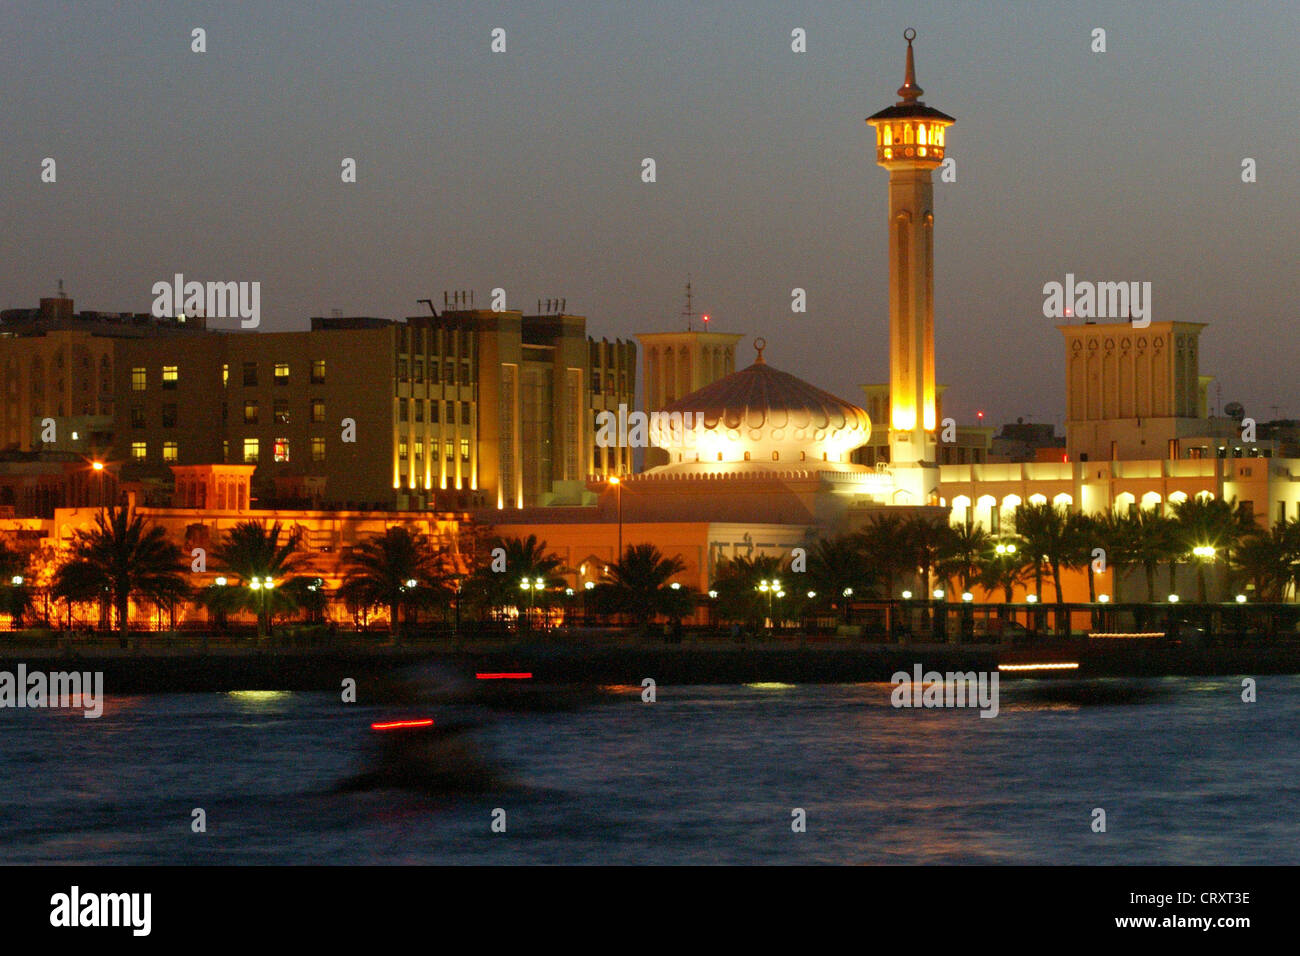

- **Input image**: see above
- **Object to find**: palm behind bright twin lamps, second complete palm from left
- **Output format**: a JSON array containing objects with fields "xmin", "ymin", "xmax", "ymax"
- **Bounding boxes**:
[{"xmin": 215, "ymin": 520, "xmax": 314, "ymax": 639}]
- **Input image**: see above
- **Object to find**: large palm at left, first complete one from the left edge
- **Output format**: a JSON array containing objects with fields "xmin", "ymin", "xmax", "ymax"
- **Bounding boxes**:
[{"xmin": 52, "ymin": 505, "xmax": 190, "ymax": 648}]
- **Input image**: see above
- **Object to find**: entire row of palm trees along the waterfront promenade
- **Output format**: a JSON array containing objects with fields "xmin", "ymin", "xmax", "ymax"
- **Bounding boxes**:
[{"xmin": 10, "ymin": 498, "xmax": 1300, "ymax": 641}]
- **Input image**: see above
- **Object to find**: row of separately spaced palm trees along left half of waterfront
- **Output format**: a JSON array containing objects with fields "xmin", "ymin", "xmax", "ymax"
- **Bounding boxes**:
[{"xmin": 0, "ymin": 506, "xmax": 696, "ymax": 646}]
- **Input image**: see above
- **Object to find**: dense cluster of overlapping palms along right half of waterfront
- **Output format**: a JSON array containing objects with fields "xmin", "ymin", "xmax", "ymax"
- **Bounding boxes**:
[{"xmin": 715, "ymin": 497, "xmax": 1300, "ymax": 618}]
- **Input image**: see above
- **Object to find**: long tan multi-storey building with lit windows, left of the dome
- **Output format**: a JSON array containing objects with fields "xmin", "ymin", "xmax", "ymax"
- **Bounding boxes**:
[{"xmin": 0, "ymin": 298, "xmax": 636, "ymax": 509}]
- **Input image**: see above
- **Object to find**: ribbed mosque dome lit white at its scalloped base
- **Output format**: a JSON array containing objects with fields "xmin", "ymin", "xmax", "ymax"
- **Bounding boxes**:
[{"xmin": 650, "ymin": 339, "xmax": 871, "ymax": 464}]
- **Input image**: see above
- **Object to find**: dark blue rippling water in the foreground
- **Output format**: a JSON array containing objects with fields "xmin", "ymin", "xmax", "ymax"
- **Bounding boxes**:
[{"xmin": 0, "ymin": 675, "xmax": 1300, "ymax": 864}]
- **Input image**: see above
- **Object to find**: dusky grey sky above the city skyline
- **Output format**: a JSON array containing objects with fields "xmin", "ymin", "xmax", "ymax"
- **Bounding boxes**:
[{"xmin": 0, "ymin": 0, "xmax": 1300, "ymax": 424}]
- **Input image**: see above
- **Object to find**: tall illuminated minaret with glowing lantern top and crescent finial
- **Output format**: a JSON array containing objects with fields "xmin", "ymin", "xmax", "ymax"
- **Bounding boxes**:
[{"xmin": 867, "ymin": 29, "xmax": 956, "ymax": 505}]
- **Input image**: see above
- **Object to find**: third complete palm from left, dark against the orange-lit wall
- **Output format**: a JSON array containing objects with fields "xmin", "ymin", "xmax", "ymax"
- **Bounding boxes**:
[{"xmin": 339, "ymin": 527, "xmax": 445, "ymax": 640}]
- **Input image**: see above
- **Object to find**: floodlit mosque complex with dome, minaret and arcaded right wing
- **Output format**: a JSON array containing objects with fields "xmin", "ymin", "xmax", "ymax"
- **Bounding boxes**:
[{"xmin": 489, "ymin": 30, "xmax": 1300, "ymax": 600}]
